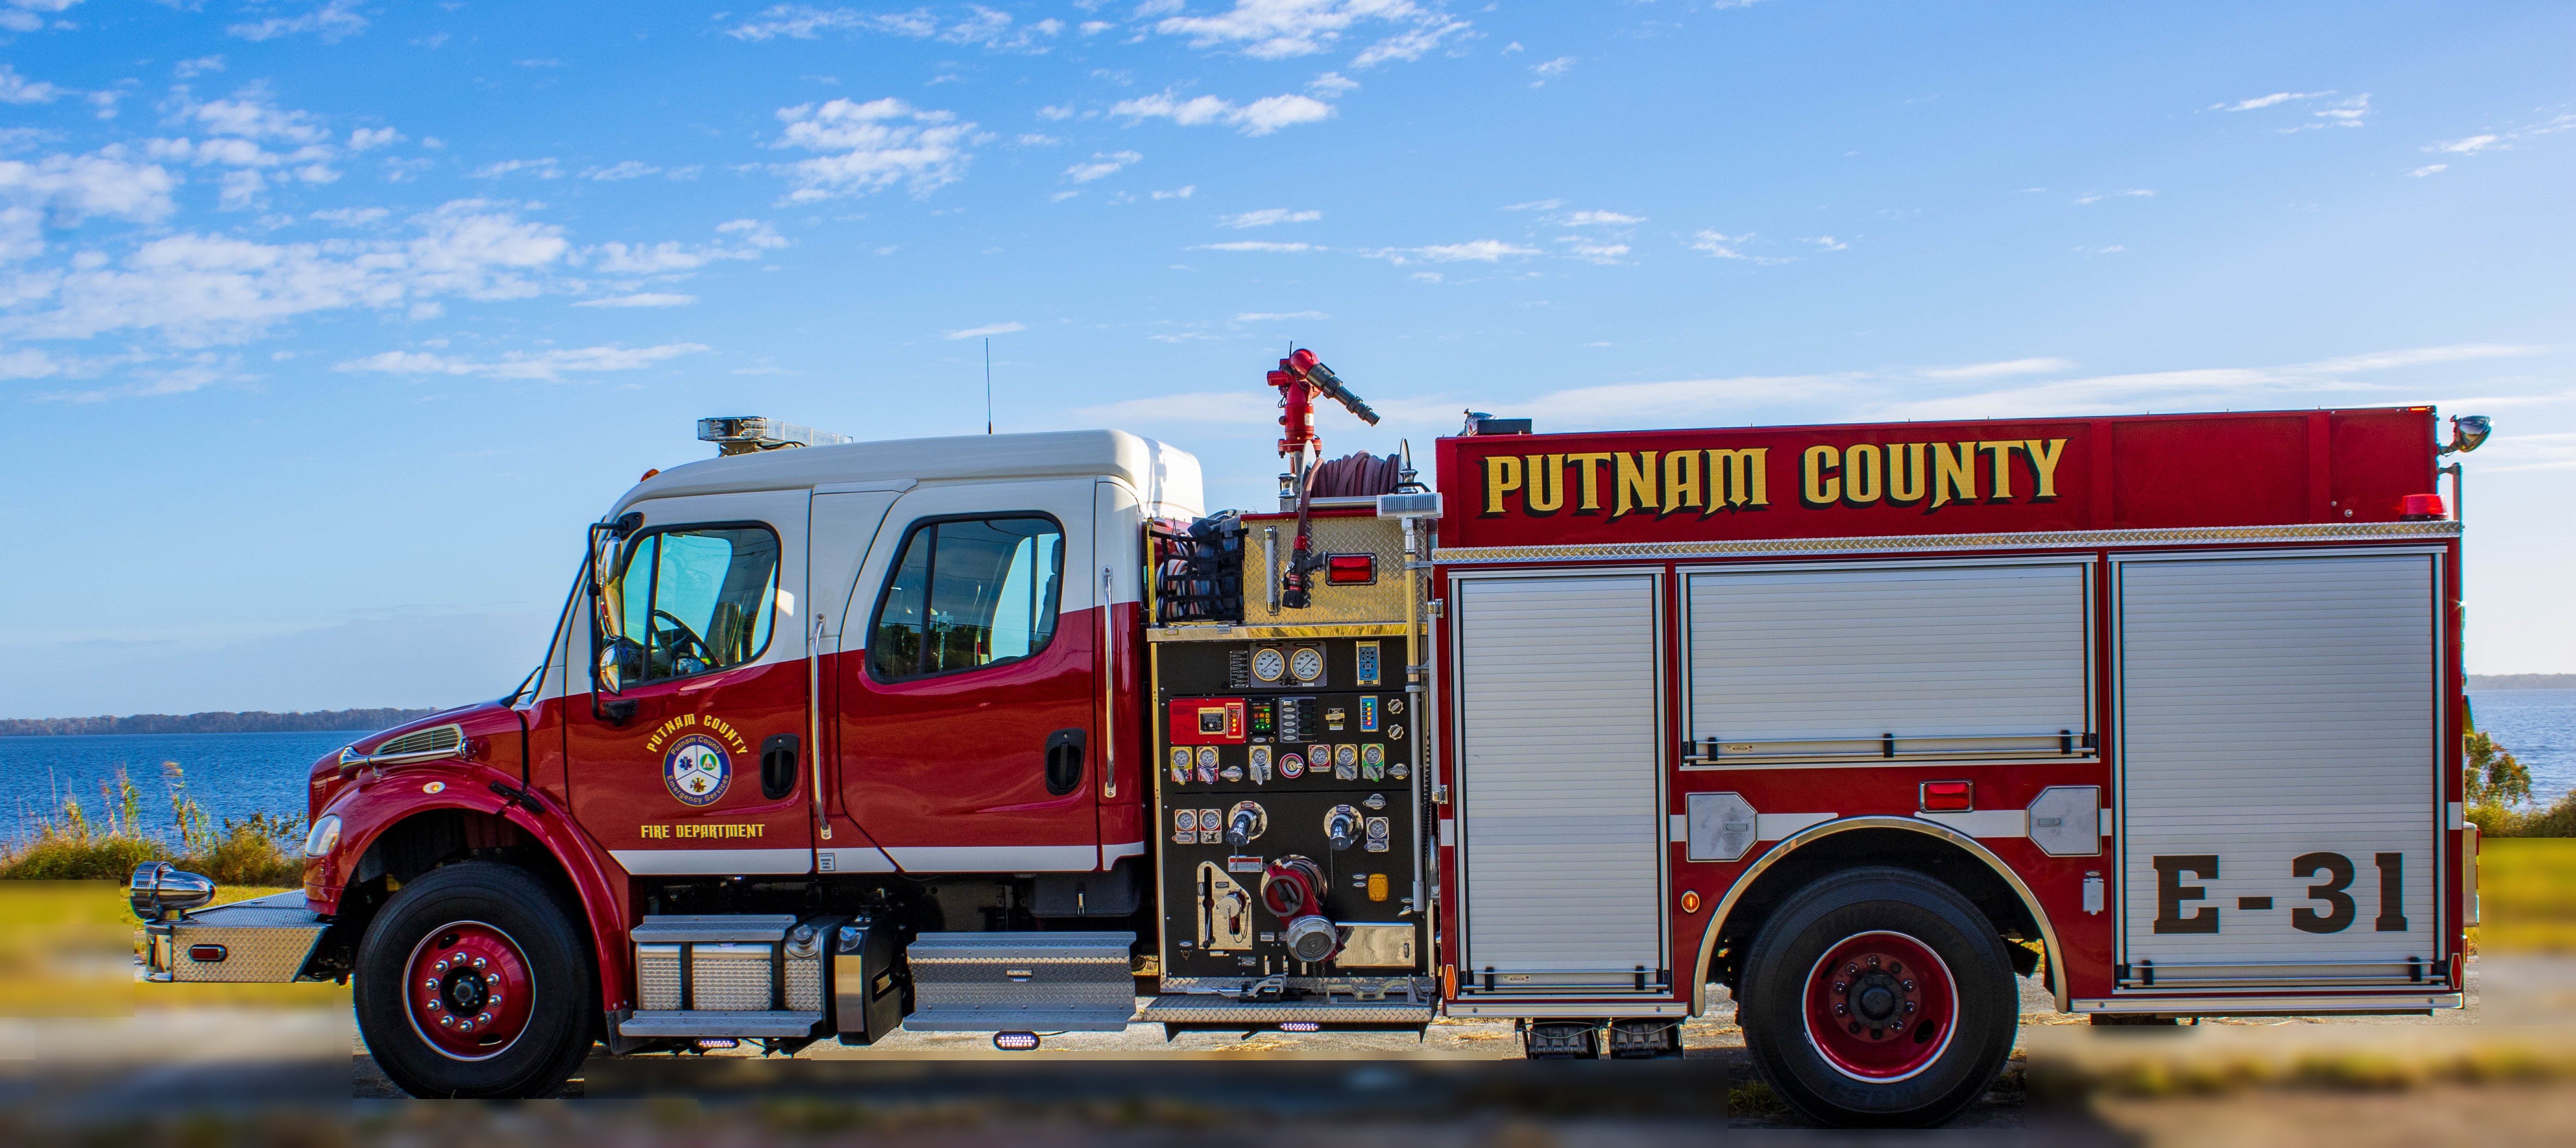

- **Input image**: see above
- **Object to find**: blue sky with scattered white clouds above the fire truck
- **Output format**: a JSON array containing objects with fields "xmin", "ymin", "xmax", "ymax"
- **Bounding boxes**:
[{"xmin": 0, "ymin": 0, "xmax": 2576, "ymax": 718}]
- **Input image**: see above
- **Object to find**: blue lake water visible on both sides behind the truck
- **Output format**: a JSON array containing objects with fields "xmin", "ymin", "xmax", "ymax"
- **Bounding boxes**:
[{"xmin": 0, "ymin": 690, "xmax": 2576, "ymax": 839}]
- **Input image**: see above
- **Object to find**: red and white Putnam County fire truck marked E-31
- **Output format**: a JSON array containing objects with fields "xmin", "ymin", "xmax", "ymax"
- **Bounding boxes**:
[{"xmin": 131, "ymin": 350, "xmax": 2488, "ymax": 1125}]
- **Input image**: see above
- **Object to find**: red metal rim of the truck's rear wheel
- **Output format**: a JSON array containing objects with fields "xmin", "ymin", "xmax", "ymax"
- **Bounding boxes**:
[{"xmin": 1806, "ymin": 932, "xmax": 1958, "ymax": 1084}]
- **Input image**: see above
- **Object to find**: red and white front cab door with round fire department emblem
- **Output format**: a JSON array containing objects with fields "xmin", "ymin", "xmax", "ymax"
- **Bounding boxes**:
[{"xmin": 564, "ymin": 489, "xmax": 814, "ymax": 875}]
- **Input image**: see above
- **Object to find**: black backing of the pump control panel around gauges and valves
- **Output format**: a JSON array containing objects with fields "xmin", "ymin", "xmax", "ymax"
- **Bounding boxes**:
[{"xmin": 1149, "ymin": 636, "xmax": 1430, "ymax": 978}]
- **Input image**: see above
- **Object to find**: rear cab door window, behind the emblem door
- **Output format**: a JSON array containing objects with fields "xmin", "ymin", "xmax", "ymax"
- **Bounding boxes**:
[{"xmin": 868, "ymin": 515, "xmax": 1064, "ymax": 682}]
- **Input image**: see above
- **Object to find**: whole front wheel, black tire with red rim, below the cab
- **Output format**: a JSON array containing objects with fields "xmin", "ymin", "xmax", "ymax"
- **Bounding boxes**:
[{"xmin": 356, "ymin": 862, "xmax": 598, "ymax": 1099}]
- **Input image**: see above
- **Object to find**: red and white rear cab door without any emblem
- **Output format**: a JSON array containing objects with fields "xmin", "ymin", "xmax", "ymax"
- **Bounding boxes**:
[{"xmin": 834, "ymin": 479, "xmax": 1102, "ymax": 873}]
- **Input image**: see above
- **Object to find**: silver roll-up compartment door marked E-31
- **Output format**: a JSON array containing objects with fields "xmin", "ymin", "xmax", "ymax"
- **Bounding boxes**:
[{"xmin": 2117, "ymin": 553, "xmax": 2442, "ymax": 988}]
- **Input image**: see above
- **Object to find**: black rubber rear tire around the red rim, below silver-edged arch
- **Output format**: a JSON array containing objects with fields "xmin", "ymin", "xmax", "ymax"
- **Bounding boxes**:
[{"xmin": 1736, "ymin": 867, "xmax": 2022, "ymax": 1127}]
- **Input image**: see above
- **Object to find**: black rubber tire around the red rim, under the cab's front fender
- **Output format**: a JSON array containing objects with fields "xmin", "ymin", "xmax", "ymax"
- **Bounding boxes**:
[{"xmin": 356, "ymin": 862, "xmax": 600, "ymax": 1099}]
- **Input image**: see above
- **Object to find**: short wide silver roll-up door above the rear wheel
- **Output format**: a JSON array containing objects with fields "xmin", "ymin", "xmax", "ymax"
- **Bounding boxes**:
[{"xmin": 1685, "ymin": 564, "xmax": 2097, "ymax": 764}]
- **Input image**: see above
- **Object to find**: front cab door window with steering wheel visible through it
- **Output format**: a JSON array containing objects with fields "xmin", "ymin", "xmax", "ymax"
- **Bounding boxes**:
[{"xmin": 611, "ymin": 525, "xmax": 778, "ymax": 682}]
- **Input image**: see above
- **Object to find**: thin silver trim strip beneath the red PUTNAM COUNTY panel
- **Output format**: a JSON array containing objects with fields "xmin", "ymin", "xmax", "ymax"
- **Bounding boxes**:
[{"xmin": 1432, "ymin": 520, "xmax": 2460, "ymax": 564}]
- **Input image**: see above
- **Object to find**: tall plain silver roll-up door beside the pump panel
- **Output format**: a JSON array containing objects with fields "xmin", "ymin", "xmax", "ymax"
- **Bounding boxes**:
[{"xmin": 1453, "ymin": 574, "xmax": 1672, "ymax": 994}]
